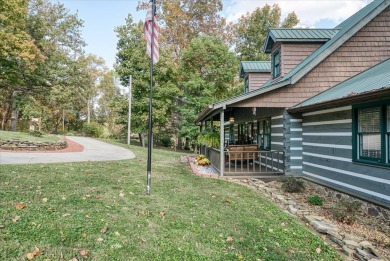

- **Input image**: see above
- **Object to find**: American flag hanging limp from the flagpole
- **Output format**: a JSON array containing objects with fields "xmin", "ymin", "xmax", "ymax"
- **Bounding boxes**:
[{"xmin": 144, "ymin": 0, "xmax": 160, "ymax": 64}]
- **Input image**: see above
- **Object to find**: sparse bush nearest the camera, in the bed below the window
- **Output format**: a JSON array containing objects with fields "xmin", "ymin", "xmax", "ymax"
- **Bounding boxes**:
[{"xmin": 332, "ymin": 199, "xmax": 362, "ymax": 224}]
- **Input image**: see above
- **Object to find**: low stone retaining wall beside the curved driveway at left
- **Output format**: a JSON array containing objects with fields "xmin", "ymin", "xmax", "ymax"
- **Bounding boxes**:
[{"xmin": 0, "ymin": 137, "xmax": 67, "ymax": 151}]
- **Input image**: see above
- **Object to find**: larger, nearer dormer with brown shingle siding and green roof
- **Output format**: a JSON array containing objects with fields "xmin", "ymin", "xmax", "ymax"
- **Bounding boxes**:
[{"xmin": 263, "ymin": 28, "xmax": 339, "ymax": 79}]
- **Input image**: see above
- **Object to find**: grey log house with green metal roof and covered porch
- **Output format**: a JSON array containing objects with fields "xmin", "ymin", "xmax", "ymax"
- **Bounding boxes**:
[{"xmin": 196, "ymin": 0, "xmax": 390, "ymax": 208}]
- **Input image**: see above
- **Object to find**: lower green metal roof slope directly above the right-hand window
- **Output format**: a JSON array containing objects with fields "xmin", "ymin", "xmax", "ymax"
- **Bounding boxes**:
[{"xmin": 292, "ymin": 59, "xmax": 390, "ymax": 109}]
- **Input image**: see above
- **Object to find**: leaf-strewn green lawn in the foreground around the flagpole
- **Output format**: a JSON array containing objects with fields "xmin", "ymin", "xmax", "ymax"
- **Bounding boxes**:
[{"xmin": 0, "ymin": 142, "xmax": 341, "ymax": 261}]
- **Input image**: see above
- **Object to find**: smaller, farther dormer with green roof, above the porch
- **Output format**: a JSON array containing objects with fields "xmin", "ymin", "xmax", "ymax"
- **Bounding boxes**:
[{"xmin": 240, "ymin": 61, "xmax": 271, "ymax": 93}]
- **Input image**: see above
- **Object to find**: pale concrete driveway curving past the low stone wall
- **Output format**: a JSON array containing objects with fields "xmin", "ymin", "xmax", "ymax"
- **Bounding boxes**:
[{"xmin": 0, "ymin": 136, "xmax": 135, "ymax": 164}]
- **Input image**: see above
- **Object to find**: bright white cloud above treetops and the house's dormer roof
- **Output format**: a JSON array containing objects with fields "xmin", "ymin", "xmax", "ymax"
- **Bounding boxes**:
[{"xmin": 223, "ymin": 0, "xmax": 371, "ymax": 27}]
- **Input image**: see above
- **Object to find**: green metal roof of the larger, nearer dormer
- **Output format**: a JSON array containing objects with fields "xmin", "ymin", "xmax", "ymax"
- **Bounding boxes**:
[{"xmin": 264, "ymin": 28, "xmax": 339, "ymax": 53}]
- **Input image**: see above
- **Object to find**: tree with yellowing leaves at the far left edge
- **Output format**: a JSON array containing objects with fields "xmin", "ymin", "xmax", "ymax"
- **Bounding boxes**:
[{"xmin": 0, "ymin": 0, "xmax": 44, "ymax": 130}]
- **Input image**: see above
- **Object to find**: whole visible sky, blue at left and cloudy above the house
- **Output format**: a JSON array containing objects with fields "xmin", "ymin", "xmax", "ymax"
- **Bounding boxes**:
[{"xmin": 52, "ymin": 0, "xmax": 370, "ymax": 68}]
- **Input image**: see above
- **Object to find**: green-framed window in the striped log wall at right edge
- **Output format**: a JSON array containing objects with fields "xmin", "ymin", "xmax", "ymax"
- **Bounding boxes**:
[{"xmin": 353, "ymin": 104, "xmax": 390, "ymax": 165}]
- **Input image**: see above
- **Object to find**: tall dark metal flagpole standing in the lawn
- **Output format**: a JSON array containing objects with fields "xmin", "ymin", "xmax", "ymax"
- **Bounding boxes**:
[{"xmin": 146, "ymin": 0, "xmax": 156, "ymax": 195}]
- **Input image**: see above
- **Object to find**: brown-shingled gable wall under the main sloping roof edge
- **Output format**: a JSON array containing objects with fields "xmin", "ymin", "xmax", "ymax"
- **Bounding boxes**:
[{"xmin": 230, "ymin": 7, "xmax": 390, "ymax": 107}]
